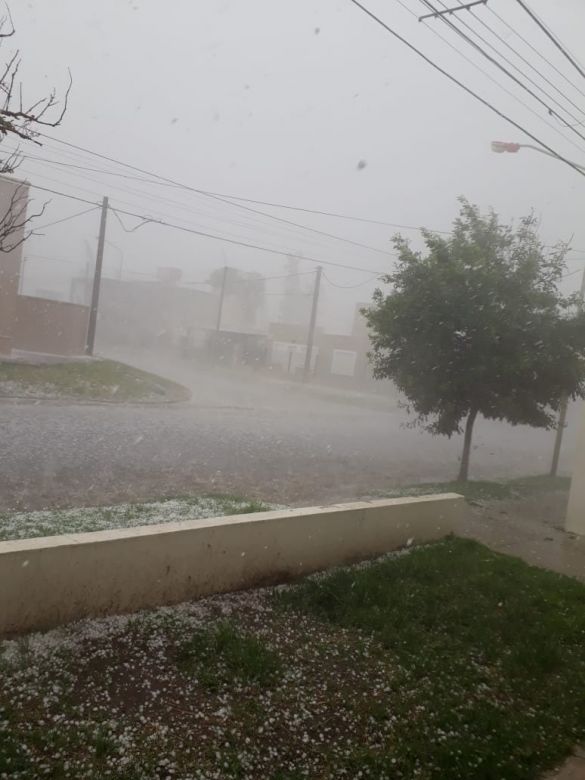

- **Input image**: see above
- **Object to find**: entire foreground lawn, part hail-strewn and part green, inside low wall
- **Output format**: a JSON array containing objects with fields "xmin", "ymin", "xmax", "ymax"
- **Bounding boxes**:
[{"xmin": 0, "ymin": 539, "xmax": 585, "ymax": 780}]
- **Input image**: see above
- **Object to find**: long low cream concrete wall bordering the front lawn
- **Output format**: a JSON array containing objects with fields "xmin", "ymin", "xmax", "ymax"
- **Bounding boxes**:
[{"xmin": 0, "ymin": 494, "xmax": 465, "ymax": 635}]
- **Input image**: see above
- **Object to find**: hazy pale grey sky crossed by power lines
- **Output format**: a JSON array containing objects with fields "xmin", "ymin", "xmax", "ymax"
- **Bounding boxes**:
[{"xmin": 8, "ymin": 0, "xmax": 585, "ymax": 328}]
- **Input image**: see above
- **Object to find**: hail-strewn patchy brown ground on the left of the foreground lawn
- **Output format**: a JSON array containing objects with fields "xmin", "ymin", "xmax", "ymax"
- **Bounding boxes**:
[{"xmin": 0, "ymin": 556, "xmax": 404, "ymax": 780}]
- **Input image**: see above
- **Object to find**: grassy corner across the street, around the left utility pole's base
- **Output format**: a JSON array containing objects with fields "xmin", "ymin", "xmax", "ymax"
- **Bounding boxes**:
[{"xmin": 0, "ymin": 360, "xmax": 190, "ymax": 403}]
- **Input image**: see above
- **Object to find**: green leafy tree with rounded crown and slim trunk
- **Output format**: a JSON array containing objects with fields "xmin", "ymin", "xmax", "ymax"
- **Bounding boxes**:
[{"xmin": 363, "ymin": 198, "xmax": 585, "ymax": 480}]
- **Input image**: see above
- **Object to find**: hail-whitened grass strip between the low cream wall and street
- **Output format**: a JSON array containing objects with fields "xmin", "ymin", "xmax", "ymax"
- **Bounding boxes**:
[{"xmin": 0, "ymin": 495, "xmax": 276, "ymax": 542}]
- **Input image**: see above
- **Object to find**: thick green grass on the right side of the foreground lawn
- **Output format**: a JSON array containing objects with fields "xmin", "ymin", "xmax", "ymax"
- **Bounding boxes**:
[{"xmin": 278, "ymin": 539, "xmax": 585, "ymax": 780}]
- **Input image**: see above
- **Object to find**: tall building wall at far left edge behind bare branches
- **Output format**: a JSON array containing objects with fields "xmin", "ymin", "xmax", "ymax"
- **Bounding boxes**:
[{"xmin": 0, "ymin": 176, "xmax": 28, "ymax": 355}]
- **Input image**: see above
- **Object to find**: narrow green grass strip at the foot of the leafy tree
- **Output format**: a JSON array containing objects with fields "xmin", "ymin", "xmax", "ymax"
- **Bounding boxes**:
[{"xmin": 381, "ymin": 476, "xmax": 571, "ymax": 503}]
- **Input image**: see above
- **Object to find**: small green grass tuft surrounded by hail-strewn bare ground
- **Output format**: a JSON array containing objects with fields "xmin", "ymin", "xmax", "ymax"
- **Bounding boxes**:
[{"xmin": 176, "ymin": 621, "xmax": 281, "ymax": 690}]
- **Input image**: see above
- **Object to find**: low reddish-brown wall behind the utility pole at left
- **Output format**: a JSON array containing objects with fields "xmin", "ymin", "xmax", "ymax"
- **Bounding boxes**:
[{"xmin": 12, "ymin": 295, "xmax": 89, "ymax": 355}]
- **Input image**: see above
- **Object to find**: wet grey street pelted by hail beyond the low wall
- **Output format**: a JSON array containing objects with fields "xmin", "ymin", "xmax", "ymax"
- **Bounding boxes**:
[{"xmin": 0, "ymin": 348, "xmax": 575, "ymax": 508}]
